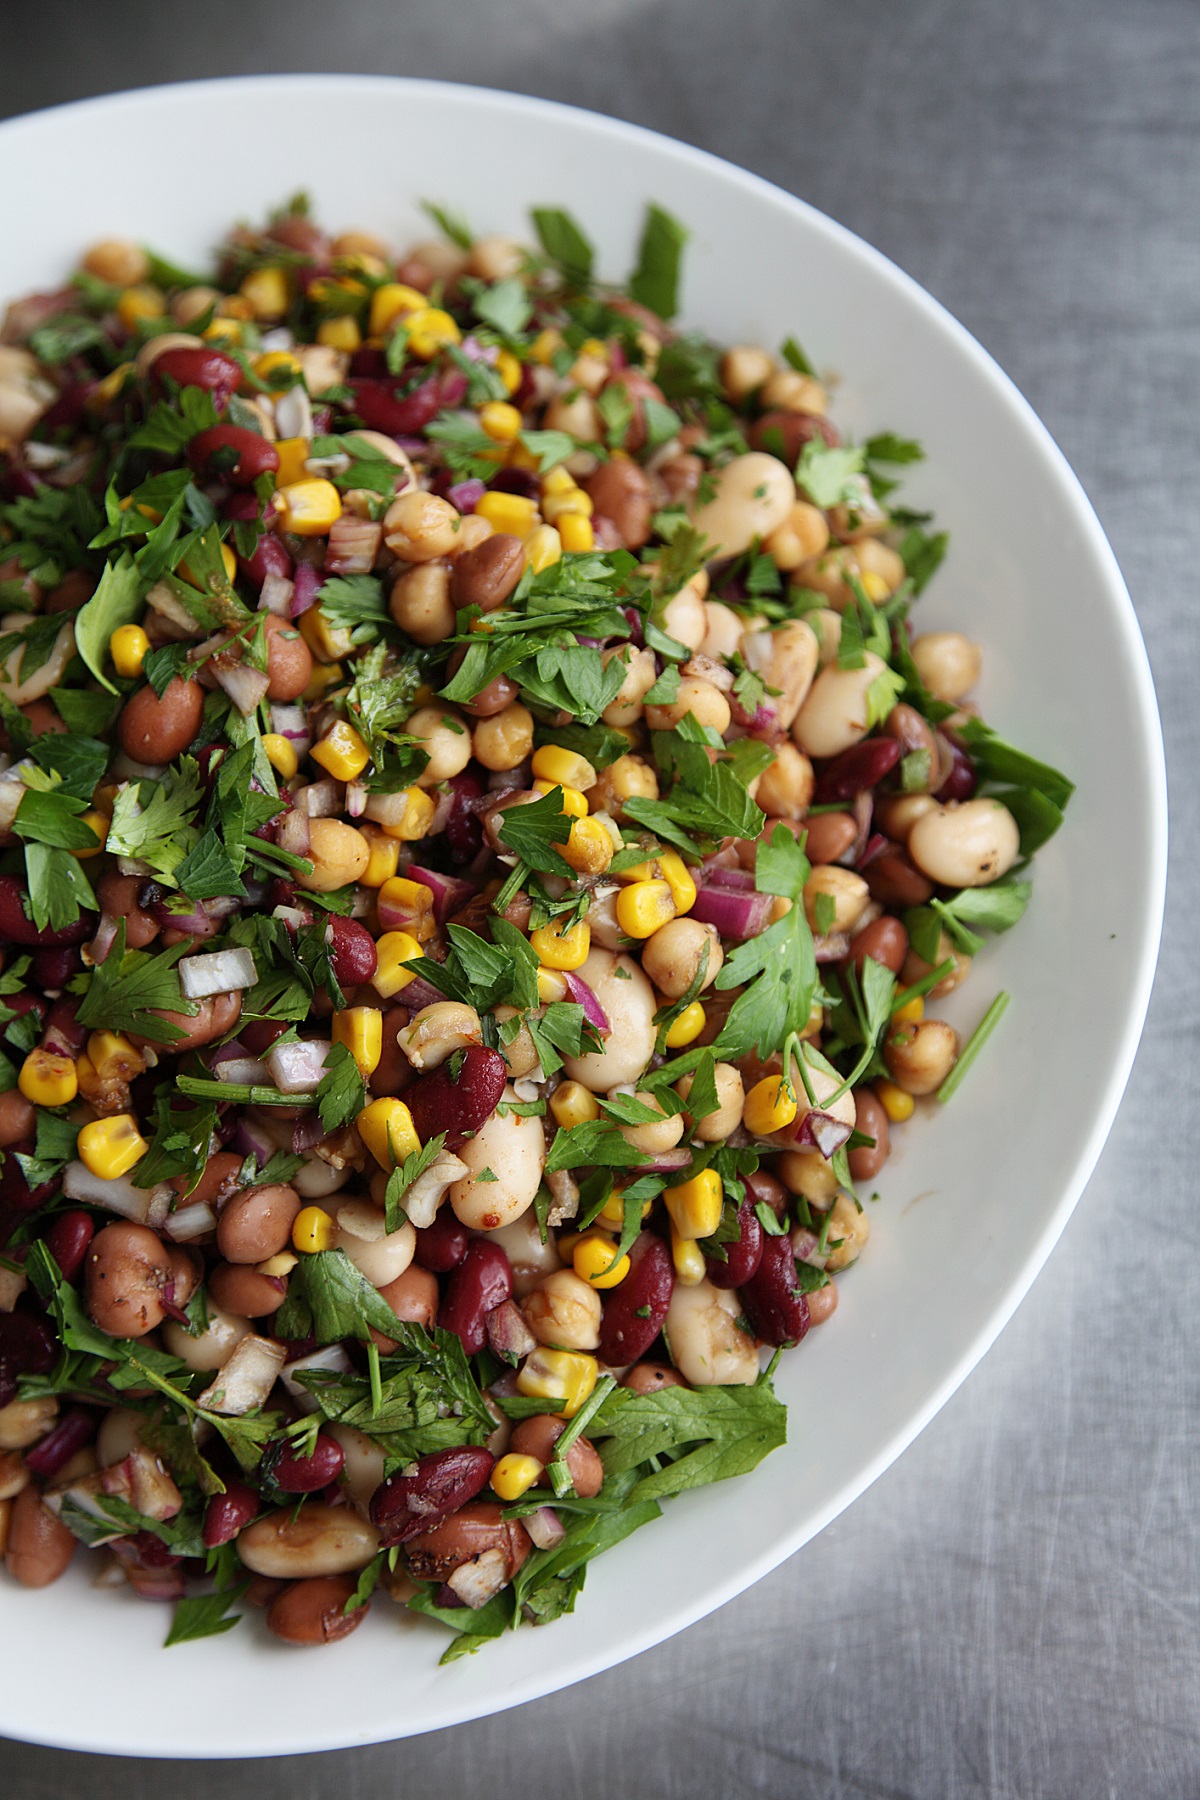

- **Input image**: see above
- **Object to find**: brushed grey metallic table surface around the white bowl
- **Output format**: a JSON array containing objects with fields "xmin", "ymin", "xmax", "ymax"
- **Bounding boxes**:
[{"xmin": 0, "ymin": 0, "xmax": 1200, "ymax": 1800}]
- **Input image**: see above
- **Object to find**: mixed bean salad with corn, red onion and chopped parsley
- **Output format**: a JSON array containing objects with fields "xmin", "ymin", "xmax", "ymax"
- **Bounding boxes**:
[{"xmin": 0, "ymin": 196, "xmax": 1070, "ymax": 1660}]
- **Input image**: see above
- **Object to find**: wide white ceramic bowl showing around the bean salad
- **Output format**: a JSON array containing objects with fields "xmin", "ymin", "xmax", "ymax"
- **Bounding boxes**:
[{"xmin": 0, "ymin": 76, "xmax": 1166, "ymax": 1757}]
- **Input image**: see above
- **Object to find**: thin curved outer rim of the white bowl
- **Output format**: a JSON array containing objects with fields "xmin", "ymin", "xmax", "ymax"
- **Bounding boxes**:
[{"xmin": 0, "ymin": 72, "xmax": 1168, "ymax": 1759}]
